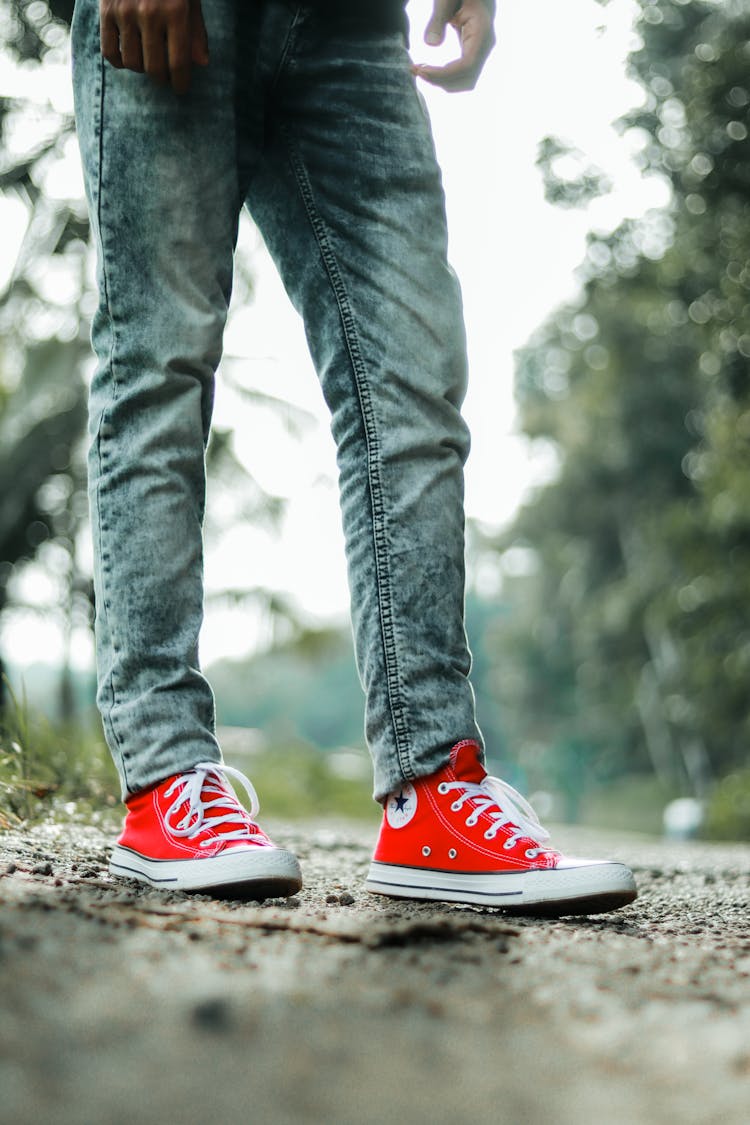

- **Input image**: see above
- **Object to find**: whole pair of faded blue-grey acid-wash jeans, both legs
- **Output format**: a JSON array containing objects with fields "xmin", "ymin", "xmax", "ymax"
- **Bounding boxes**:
[{"xmin": 73, "ymin": 0, "xmax": 480, "ymax": 800}]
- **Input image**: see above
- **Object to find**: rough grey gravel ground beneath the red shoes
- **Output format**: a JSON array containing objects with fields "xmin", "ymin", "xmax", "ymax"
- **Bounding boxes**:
[{"xmin": 0, "ymin": 825, "xmax": 750, "ymax": 1125}]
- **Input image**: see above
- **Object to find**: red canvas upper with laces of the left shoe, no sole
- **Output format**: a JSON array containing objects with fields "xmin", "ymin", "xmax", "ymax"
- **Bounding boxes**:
[{"xmin": 118, "ymin": 763, "xmax": 273, "ymax": 860}]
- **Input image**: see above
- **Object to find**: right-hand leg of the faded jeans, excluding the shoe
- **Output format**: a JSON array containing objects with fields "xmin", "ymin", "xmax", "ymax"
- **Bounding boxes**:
[{"xmin": 247, "ymin": 9, "xmax": 480, "ymax": 800}]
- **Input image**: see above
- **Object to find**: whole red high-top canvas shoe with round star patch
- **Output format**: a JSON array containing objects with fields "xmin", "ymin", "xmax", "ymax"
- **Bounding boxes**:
[{"xmin": 365, "ymin": 740, "xmax": 638, "ymax": 915}]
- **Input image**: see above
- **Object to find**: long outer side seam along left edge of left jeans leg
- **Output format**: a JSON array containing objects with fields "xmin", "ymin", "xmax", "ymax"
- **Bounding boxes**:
[{"xmin": 96, "ymin": 57, "xmax": 130, "ymax": 791}]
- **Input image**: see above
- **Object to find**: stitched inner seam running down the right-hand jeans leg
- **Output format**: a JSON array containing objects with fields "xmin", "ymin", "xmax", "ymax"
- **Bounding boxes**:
[{"xmin": 280, "ymin": 126, "xmax": 415, "ymax": 780}]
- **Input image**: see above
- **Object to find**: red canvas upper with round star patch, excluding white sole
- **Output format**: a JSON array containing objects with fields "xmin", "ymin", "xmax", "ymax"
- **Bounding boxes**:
[{"xmin": 373, "ymin": 740, "xmax": 560, "ymax": 873}]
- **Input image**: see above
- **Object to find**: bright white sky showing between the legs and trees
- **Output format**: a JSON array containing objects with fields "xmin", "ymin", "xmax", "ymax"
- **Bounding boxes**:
[{"xmin": 0, "ymin": 0, "xmax": 667, "ymax": 664}]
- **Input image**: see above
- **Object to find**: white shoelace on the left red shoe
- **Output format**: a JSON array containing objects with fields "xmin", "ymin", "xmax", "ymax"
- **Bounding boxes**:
[{"xmin": 164, "ymin": 762, "xmax": 264, "ymax": 847}]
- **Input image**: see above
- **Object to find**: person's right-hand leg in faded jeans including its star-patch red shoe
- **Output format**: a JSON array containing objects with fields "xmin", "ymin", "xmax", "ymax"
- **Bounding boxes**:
[{"xmin": 247, "ymin": 3, "xmax": 635, "ymax": 914}]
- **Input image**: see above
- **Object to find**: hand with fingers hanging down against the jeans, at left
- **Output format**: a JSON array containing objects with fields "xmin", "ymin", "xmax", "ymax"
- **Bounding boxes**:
[{"xmin": 99, "ymin": 0, "xmax": 208, "ymax": 93}]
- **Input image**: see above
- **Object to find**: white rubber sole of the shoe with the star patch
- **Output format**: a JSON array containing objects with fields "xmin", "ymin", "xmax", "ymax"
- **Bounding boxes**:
[{"xmin": 364, "ymin": 860, "xmax": 638, "ymax": 916}]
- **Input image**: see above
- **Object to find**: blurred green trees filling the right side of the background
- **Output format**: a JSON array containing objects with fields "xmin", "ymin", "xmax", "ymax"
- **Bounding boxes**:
[{"xmin": 498, "ymin": 0, "xmax": 750, "ymax": 795}]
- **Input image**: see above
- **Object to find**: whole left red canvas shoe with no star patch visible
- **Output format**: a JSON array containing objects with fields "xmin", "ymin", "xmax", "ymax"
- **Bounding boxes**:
[{"xmin": 109, "ymin": 762, "xmax": 302, "ymax": 899}]
